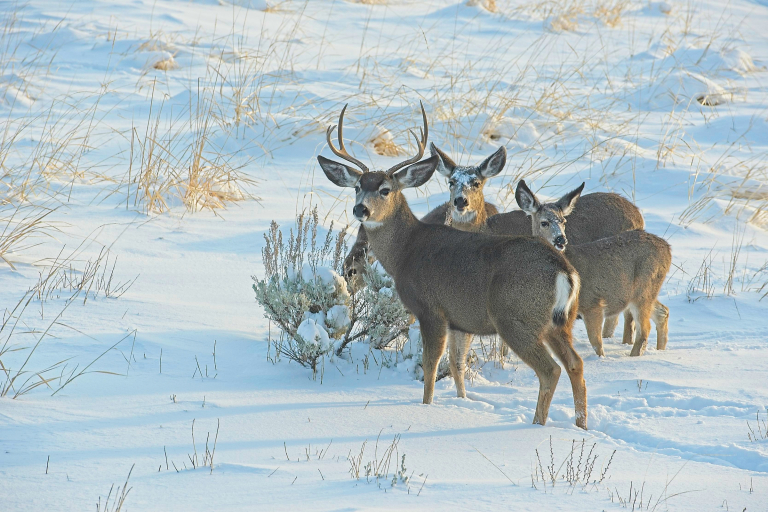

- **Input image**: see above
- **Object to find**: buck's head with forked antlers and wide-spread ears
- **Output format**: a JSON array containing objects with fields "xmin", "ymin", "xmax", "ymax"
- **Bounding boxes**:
[{"xmin": 317, "ymin": 105, "xmax": 438, "ymax": 229}]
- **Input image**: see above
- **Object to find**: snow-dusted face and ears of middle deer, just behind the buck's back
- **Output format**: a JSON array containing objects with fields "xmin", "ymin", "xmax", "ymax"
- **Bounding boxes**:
[{"xmin": 429, "ymin": 144, "xmax": 507, "ymax": 223}]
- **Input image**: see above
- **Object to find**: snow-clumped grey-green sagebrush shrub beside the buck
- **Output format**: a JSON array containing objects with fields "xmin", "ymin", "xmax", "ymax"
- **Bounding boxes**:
[{"xmin": 253, "ymin": 209, "xmax": 421, "ymax": 373}]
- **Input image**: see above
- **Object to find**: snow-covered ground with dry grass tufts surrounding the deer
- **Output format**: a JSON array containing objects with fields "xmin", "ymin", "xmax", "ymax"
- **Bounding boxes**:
[{"xmin": 0, "ymin": 0, "xmax": 768, "ymax": 511}]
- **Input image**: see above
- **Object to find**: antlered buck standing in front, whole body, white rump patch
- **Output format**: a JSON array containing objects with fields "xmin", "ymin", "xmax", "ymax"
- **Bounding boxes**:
[{"xmin": 317, "ymin": 105, "xmax": 587, "ymax": 429}]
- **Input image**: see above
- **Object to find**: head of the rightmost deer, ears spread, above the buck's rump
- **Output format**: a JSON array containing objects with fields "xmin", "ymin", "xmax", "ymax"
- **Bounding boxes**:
[{"xmin": 515, "ymin": 180, "xmax": 584, "ymax": 251}]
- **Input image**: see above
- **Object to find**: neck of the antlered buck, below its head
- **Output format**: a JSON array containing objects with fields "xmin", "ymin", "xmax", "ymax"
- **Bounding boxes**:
[{"xmin": 363, "ymin": 192, "xmax": 420, "ymax": 280}]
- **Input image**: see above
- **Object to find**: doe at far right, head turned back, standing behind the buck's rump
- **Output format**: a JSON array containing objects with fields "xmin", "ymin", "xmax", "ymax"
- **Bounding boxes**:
[{"xmin": 515, "ymin": 180, "xmax": 672, "ymax": 356}]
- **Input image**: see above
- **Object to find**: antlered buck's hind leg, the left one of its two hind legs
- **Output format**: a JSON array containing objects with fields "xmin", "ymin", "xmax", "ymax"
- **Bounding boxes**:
[{"xmin": 495, "ymin": 319, "xmax": 560, "ymax": 425}]
